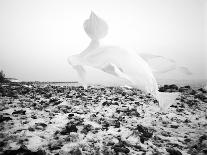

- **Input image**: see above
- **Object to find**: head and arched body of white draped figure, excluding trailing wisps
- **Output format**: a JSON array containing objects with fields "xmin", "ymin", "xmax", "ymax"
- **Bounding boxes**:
[{"xmin": 68, "ymin": 12, "xmax": 158, "ymax": 97}]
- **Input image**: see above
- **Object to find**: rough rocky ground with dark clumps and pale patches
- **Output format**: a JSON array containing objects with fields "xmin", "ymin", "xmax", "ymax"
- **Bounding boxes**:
[{"xmin": 0, "ymin": 84, "xmax": 207, "ymax": 155}]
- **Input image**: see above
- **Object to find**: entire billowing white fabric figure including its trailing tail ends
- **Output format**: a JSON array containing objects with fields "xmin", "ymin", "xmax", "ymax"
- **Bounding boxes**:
[{"xmin": 68, "ymin": 12, "xmax": 191, "ymax": 107}]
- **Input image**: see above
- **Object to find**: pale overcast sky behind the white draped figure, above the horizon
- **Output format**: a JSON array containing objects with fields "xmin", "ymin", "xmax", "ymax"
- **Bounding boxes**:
[{"xmin": 0, "ymin": 0, "xmax": 207, "ymax": 81}]
